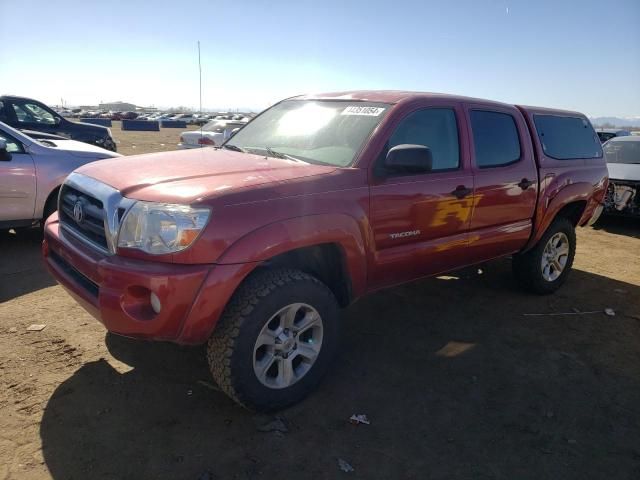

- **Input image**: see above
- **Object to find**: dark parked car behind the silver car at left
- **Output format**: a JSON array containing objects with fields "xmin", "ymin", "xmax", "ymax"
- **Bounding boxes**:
[{"xmin": 0, "ymin": 95, "xmax": 116, "ymax": 152}]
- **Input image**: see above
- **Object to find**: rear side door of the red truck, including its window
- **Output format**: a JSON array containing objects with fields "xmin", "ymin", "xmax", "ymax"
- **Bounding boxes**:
[{"xmin": 465, "ymin": 104, "xmax": 538, "ymax": 263}]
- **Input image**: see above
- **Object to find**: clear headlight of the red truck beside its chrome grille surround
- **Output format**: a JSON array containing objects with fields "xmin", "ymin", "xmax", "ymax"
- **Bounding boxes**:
[{"xmin": 118, "ymin": 202, "xmax": 210, "ymax": 255}]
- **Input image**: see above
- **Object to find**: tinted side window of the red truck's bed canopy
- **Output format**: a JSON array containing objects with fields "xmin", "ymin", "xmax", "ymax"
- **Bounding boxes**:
[{"xmin": 533, "ymin": 115, "xmax": 602, "ymax": 160}]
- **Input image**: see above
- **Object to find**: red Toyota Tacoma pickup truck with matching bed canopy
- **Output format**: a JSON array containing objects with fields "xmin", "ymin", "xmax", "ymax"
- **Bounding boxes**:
[{"xmin": 43, "ymin": 91, "xmax": 607, "ymax": 410}]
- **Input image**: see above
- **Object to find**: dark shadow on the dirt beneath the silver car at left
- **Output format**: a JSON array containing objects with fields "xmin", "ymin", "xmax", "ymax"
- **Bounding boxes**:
[{"xmin": 0, "ymin": 228, "xmax": 56, "ymax": 303}]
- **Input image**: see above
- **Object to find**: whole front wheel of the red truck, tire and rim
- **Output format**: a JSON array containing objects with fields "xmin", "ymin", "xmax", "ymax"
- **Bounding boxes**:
[{"xmin": 207, "ymin": 269, "xmax": 339, "ymax": 411}]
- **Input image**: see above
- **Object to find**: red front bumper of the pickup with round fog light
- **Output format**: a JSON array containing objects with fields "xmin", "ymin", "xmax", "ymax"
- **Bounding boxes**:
[{"xmin": 42, "ymin": 213, "xmax": 254, "ymax": 344}]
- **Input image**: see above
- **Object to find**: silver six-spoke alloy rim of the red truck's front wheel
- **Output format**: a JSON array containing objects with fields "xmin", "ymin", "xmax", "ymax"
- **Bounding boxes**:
[{"xmin": 253, "ymin": 303, "xmax": 323, "ymax": 388}]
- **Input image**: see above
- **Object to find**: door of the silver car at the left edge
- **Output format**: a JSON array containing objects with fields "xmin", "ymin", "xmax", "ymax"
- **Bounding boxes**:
[{"xmin": 0, "ymin": 130, "xmax": 36, "ymax": 225}]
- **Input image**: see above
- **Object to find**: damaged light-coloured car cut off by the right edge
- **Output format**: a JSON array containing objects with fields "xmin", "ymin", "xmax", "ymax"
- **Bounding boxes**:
[{"xmin": 602, "ymin": 135, "xmax": 640, "ymax": 218}]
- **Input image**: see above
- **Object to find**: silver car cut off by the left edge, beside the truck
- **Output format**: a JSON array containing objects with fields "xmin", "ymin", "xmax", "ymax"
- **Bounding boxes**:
[{"xmin": 0, "ymin": 123, "xmax": 121, "ymax": 229}]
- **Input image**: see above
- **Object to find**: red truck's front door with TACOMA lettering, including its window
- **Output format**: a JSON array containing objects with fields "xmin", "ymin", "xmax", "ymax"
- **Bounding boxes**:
[{"xmin": 369, "ymin": 102, "xmax": 473, "ymax": 288}]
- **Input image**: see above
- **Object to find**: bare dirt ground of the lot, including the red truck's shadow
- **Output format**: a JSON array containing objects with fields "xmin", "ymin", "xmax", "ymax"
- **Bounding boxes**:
[{"xmin": 0, "ymin": 128, "xmax": 640, "ymax": 480}]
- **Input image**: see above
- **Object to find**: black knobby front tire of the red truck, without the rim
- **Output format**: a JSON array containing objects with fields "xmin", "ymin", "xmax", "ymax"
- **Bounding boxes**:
[{"xmin": 207, "ymin": 269, "xmax": 340, "ymax": 411}]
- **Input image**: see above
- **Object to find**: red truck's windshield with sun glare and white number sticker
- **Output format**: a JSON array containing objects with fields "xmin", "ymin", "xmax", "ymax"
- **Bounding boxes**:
[{"xmin": 227, "ymin": 100, "xmax": 389, "ymax": 167}]
